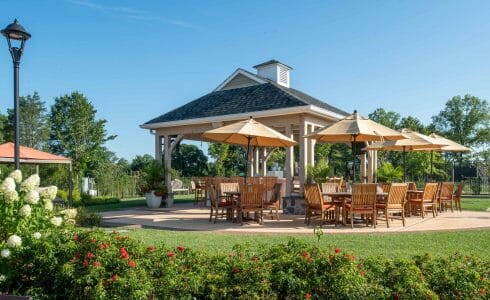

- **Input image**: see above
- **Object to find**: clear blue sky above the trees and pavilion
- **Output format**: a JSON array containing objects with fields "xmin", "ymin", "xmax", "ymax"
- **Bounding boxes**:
[{"xmin": 0, "ymin": 0, "xmax": 490, "ymax": 159}]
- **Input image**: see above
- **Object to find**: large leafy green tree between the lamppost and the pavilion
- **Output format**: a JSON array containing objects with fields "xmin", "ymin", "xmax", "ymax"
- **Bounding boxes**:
[{"xmin": 49, "ymin": 92, "xmax": 116, "ymax": 177}]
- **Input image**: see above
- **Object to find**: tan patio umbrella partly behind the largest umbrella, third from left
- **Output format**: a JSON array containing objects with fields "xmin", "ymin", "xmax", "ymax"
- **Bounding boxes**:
[{"xmin": 364, "ymin": 128, "xmax": 447, "ymax": 181}]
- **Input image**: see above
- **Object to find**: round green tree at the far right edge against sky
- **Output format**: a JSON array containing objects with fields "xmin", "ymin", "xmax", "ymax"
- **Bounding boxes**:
[{"xmin": 432, "ymin": 95, "xmax": 490, "ymax": 146}]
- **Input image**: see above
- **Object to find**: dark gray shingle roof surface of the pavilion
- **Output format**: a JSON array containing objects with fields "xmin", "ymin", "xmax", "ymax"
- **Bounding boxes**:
[{"xmin": 145, "ymin": 80, "xmax": 348, "ymax": 124}]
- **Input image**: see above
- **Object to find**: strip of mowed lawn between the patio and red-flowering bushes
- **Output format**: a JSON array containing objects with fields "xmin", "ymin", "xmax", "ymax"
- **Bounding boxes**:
[{"xmin": 124, "ymin": 229, "xmax": 490, "ymax": 259}]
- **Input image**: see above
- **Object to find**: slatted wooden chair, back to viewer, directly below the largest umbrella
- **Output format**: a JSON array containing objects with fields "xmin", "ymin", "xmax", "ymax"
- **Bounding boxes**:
[{"xmin": 345, "ymin": 183, "xmax": 377, "ymax": 228}]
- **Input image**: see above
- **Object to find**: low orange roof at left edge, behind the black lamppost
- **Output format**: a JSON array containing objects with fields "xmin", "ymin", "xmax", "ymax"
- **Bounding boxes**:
[{"xmin": 0, "ymin": 142, "xmax": 71, "ymax": 164}]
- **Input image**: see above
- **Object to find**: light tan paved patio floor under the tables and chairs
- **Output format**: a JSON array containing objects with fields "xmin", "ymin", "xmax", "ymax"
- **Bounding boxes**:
[{"xmin": 102, "ymin": 204, "xmax": 490, "ymax": 234}]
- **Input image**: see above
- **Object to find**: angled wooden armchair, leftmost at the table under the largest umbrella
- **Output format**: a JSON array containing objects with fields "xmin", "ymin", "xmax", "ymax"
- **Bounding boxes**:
[{"xmin": 305, "ymin": 183, "xmax": 335, "ymax": 226}]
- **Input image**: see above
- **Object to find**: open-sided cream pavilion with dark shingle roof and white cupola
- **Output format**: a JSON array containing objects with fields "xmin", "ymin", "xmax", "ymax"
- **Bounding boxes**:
[{"xmin": 140, "ymin": 60, "xmax": 378, "ymax": 195}]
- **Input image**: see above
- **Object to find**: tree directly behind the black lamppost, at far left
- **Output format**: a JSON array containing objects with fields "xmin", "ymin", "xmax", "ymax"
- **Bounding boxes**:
[{"xmin": 5, "ymin": 92, "xmax": 49, "ymax": 150}]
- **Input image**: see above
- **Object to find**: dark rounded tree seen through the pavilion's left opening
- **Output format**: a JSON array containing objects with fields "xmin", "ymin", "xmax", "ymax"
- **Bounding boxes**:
[{"xmin": 172, "ymin": 144, "xmax": 208, "ymax": 177}]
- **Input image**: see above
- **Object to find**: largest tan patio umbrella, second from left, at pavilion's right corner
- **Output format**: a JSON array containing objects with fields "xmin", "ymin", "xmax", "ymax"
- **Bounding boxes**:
[{"xmin": 305, "ymin": 110, "xmax": 405, "ymax": 181}]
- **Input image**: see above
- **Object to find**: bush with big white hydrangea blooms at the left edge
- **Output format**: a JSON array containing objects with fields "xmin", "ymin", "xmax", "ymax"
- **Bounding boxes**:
[{"xmin": 0, "ymin": 170, "xmax": 77, "ymax": 286}]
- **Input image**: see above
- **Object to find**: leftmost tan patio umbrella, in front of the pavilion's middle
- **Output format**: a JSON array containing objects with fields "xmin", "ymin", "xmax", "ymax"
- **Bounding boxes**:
[{"xmin": 203, "ymin": 117, "xmax": 296, "ymax": 178}]
